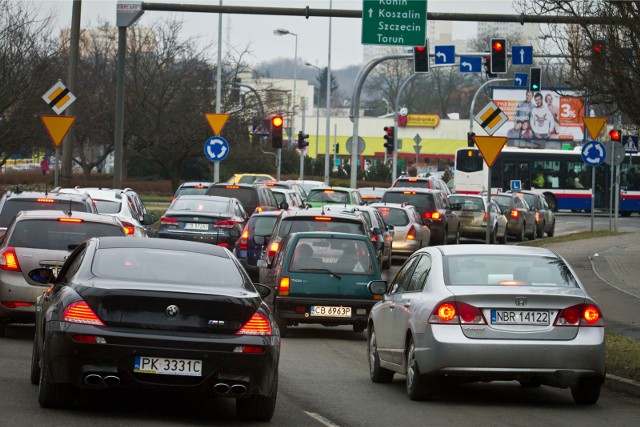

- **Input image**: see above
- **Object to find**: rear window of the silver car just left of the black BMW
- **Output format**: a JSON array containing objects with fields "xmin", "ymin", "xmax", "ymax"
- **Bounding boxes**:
[{"xmin": 9, "ymin": 218, "xmax": 124, "ymax": 251}]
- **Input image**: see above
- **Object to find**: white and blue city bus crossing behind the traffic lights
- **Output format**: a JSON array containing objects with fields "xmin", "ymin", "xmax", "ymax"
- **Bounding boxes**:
[{"xmin": 454, "ymin": 147, "xmax": 640, "ymax": 216}]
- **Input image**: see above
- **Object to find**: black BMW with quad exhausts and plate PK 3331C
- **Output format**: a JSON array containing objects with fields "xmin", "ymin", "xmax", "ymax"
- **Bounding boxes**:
[{"xmin": 29, "ymin": 238, "xmax": 280, "ymax": 421}]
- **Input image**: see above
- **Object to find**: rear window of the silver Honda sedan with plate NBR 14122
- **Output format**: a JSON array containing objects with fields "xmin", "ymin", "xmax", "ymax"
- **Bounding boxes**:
[{"xmin": 444, "ymin": 254, "xmax": 578, "ymax": 288}]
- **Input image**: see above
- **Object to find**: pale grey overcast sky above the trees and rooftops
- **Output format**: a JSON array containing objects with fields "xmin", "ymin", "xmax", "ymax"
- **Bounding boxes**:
[{"xmin": 36, "ymin": 0, "xmax": 515, "ymax": 69}]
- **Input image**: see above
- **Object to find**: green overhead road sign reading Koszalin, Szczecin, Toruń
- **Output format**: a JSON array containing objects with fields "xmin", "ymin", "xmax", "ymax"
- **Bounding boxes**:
[{"xmin": 362, "ymin": 0, "xmax": 427, "ymax": 46}]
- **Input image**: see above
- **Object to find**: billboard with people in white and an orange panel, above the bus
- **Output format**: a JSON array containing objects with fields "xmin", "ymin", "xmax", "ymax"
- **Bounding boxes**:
[{"xmin": 493, "ymin": 88, "xmax": 585, "ymax": 148}]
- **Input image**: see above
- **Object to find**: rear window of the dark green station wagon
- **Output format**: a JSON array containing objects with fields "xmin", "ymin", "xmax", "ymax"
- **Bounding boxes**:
[{"xmin": 289, "ymin": 237, "xmax": 376, "ymax": 274}]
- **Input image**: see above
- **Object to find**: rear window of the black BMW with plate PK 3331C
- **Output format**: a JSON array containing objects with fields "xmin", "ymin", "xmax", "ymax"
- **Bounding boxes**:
[{"xmin": 91, "ymin": 248, "xmax": 244, "ymax": 289}]
